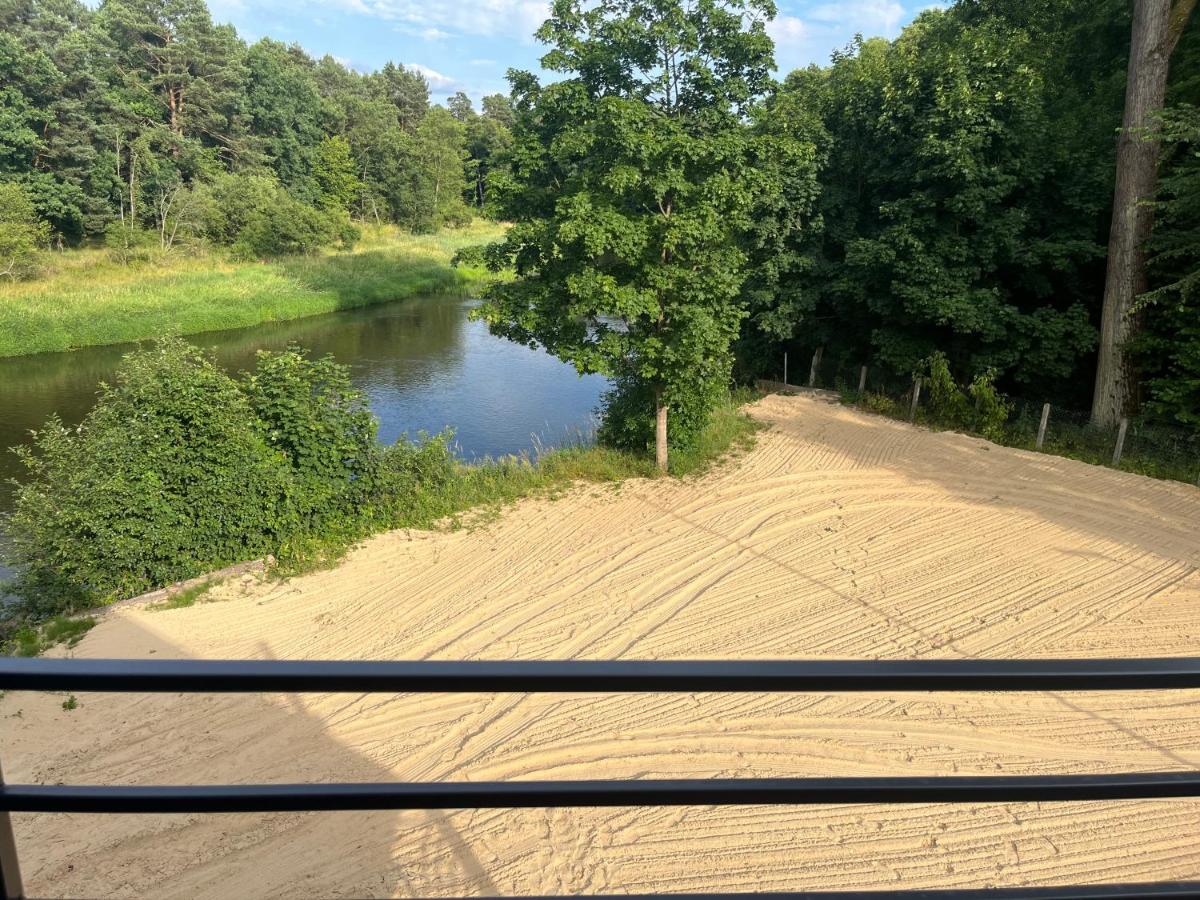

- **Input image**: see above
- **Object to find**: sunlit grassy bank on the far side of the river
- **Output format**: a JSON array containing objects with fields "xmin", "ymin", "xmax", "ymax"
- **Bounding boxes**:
[{"xmin": 0, "ymin": 222, "xmax": 502, "ymax": 356}]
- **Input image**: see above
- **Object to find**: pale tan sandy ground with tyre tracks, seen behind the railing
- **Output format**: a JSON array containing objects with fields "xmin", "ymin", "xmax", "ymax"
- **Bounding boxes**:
[{"xmin": 0, "ymin": 397, "xmax": 1200, "ymax": 898}]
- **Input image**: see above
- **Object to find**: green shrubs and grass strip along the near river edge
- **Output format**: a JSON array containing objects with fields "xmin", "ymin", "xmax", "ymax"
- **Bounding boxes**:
[{"xmin": 0, "ymin": 337, "xmax": 754, "ymax": 642}]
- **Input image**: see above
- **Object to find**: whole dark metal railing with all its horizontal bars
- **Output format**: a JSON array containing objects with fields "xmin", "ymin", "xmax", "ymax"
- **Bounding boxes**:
[{"xmin": 0, "ymin": 658, "xmax": 1200, "ymax": 900}]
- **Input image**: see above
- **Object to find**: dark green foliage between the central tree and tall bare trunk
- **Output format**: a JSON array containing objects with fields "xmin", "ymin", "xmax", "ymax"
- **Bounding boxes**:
[{"xmin": 739, "ymin": 0, "xmax": 1137, "ymax": 406}]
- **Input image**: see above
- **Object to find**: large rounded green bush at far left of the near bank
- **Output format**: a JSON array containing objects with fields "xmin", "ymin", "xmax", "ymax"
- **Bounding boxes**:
[{"xmin": 7, "ymin": 340, "xmax": 295, "ymax": 613}]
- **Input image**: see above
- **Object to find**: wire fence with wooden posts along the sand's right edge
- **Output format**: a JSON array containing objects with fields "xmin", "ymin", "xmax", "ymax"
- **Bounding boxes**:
[{"xmin": 768, "ymin": 353, "xmax": 1200, "ymax": 494}]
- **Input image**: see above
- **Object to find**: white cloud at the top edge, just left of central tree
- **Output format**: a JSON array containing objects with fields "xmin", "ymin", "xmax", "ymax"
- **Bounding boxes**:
[{"xmin": 321, "ymin": 0, "xmax": 550, "ymax": 40}]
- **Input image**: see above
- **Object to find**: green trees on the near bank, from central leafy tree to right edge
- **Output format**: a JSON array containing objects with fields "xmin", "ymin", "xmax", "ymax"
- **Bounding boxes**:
[{"xmin": 485, "ymin": 0, "xmax": 1200, "ymax": 458}]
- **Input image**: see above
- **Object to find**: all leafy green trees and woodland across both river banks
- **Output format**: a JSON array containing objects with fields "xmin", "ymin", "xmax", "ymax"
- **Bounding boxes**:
[{"xmin": 0, "ymin": 0, "xmax": 1200, "ymax": 436}]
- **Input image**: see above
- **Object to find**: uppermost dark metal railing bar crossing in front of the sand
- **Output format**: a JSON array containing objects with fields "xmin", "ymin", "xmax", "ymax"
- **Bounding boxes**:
[{"xmin": 0, "ymin": 658, "xmax": 1200, "ymax": 694}]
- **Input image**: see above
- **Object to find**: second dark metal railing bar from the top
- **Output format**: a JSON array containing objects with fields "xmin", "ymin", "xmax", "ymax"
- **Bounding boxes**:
[{"xmin": 7, "ymin": 772, "xmax": 1200, "ymax": 814}]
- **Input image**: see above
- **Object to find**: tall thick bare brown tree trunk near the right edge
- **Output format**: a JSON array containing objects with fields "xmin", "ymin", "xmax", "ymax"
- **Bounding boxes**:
[{"xmin": 1092, "ymin": 0, "xmax": 1196, "ymax": 426}]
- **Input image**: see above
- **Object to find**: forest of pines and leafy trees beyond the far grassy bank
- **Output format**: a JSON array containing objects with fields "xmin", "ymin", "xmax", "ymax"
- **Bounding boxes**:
[{"xmin": 0, "ymin": 0, "xmax": 511, "ymax": 256}]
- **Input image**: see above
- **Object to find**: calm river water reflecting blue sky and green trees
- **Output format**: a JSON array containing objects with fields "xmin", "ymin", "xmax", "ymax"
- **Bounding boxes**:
[{"xmin": 0, "ymin": 296, "xmax": 607, "ymax": 588}]
